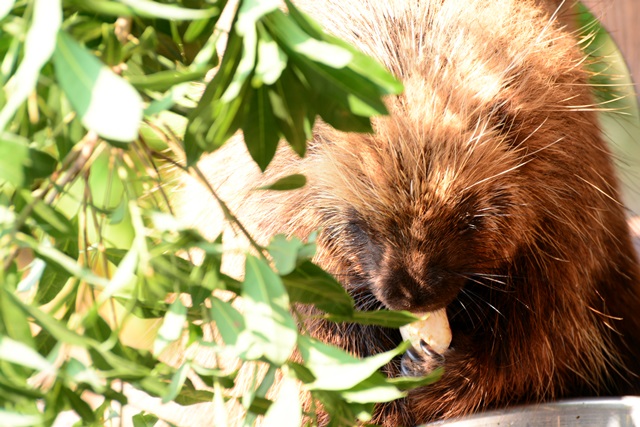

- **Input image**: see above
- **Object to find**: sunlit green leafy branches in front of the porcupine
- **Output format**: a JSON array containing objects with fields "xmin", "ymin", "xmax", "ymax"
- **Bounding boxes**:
[{"xmin": 0, "ymin": 0, "xmax": 433, "ymax": 426}]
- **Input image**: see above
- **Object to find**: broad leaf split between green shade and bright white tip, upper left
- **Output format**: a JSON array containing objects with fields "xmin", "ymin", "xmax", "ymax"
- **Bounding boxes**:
[{"xmin": 53, "ymin": 32, "xmax": 142, "ymax": 142}]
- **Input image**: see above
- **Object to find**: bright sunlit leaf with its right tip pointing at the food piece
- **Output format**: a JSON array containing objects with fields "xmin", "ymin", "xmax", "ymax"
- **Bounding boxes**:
[{"xmin": 298, "ymin": 335, "xmax": 409, "ymax": 390}]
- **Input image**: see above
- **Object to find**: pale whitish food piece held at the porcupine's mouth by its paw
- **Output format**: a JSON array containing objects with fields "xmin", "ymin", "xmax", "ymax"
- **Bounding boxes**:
[{"xmin": 400, "ymin": 308, "xmax": 451, "ymax": 354}]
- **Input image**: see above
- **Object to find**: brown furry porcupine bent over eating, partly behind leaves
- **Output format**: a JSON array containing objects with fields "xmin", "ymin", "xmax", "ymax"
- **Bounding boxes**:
[{"xmin": 176, "ymin": 0, "xmax": 640, "ymax": 426}]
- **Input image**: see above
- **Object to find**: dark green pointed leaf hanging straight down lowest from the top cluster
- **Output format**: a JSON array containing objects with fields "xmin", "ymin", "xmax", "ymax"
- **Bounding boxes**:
[{"xmin": 242, "ymin": 87, "xmax": 280, "ymax": 172}]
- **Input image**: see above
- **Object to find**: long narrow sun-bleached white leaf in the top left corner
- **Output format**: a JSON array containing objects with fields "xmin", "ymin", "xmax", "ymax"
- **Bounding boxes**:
[{"xmin": 0, "ymin": 0, "xmax": 62, "ymax": 132}]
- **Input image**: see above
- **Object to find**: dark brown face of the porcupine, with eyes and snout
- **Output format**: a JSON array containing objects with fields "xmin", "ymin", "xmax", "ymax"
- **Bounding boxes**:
[{"xmin": 336, "ymin": 184, "xmax": 513, "ymax": 312}]
